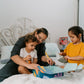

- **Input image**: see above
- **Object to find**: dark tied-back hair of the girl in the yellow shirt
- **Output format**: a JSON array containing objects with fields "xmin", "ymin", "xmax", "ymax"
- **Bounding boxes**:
[{"xmin": 68, "ymin": 26, "xmax": 84, "ymax": 42}]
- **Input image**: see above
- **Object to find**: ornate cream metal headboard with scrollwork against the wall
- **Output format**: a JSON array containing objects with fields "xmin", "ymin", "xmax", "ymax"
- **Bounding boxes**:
[{"xmin": 0, "ymin": 18, "xmax": 50, "ymax": 53}]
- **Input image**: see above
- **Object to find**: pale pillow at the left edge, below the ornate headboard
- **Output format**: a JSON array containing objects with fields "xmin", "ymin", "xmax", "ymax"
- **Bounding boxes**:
[{"xmin": 1, "ymin": 46, "xmax": 13, "ymax": 63}]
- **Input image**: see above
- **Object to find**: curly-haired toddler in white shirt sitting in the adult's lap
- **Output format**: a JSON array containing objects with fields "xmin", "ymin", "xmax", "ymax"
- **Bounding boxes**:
[{"xmin": 18, "ymin": 34, "xmax": 37, "ymax": 74}]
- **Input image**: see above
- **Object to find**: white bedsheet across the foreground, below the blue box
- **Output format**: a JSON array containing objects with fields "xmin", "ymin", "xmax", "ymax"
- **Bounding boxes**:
[{"xmin": 0, "ymin": 71, "xmax": 84, "ymax": 84}]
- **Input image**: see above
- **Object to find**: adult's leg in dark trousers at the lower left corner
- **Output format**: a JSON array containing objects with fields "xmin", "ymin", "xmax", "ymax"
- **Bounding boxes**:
[{"xmin": 0, "ymin": 60, "xmax": 18, "ymax": 82}]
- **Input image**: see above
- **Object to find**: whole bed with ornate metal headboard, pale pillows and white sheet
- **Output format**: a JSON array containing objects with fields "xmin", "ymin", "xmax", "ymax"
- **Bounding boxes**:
[{"xmin": 0, "ymin": 18, "xmax": 84, "ymax": 84}]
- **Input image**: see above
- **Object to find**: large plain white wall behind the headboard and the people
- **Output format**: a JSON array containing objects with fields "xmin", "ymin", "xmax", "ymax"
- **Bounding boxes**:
[{"xmin": 0, "ymin": 0, "xmax": 77, "ymax": 42}]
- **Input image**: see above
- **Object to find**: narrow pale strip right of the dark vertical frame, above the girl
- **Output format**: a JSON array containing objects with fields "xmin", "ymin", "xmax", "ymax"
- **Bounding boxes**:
[{"xmin": 79, "ymin": 0, "xmax": 84, "ymax": 29}]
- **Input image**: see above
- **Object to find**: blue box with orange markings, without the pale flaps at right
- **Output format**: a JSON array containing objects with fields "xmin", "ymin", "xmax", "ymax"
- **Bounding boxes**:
[{"xmin": 33, "ymin": 66, "xmax": 64, "ymax": 78}]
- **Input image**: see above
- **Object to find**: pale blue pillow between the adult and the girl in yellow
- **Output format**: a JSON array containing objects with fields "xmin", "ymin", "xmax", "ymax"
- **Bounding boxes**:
[{"xmin": 45, "ymin": 43, "xmax": 60, "ymax": 57}]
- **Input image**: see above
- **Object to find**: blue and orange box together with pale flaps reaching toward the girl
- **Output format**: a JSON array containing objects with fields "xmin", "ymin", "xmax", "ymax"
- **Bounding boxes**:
[{"xmin": 33, "ymin": 63, "xmax": 83, "ymax": 78}]
